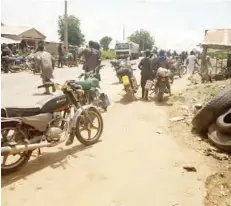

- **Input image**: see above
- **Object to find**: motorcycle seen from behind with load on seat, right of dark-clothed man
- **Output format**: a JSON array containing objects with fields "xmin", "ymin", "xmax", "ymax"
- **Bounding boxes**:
[{"xmin": 145, "ymin": 68, "xmax": 170, "ymax": 101}]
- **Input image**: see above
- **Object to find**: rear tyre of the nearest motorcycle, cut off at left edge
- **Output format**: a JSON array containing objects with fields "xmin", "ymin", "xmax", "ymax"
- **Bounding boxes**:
[{"xmin": 1, "ymin": 122, "xmax": 32, "ymax": 175}]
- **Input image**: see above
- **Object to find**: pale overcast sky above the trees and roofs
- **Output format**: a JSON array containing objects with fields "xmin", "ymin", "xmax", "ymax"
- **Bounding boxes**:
[{"xmin": 1, "ymin": 0, "xmax": 231, "ymax": 51}]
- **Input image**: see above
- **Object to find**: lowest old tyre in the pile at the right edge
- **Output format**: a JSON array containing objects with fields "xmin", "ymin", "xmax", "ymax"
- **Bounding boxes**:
[{"xmin": 208, "ymin": 124, "xmax": 231, "ymax": 153}]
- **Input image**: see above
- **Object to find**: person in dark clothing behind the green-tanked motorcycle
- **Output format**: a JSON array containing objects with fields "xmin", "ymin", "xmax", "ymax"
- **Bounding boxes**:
[{"xmin": 78, "ymin": 41, "xmax": 100, "ymax": 72}]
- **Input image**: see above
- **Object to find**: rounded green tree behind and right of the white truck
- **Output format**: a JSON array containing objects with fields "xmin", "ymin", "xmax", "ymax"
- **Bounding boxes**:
[{"xmin": 128, "ymin": 29, "xmax": 155, "ymax": 50}]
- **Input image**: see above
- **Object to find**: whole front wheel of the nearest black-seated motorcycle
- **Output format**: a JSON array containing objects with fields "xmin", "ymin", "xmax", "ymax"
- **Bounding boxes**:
[{"xmin": 76, "ymin": 108, "xmax": 103, "ymax": 146}]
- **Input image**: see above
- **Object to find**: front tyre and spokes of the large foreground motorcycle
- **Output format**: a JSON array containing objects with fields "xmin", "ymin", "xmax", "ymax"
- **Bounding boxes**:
[{"xmin": 76, "ymin": 108, "xmax": 103, "ymax": 146}]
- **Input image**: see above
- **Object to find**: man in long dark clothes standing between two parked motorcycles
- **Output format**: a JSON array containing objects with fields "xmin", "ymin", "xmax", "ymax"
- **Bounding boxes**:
[{"xmin": 138, "ymin": 50, "xmax": 153, "ymax": 100}]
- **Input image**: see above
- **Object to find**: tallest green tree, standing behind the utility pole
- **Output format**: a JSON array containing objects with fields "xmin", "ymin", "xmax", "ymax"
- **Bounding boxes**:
[{"xmin": 58, "ymin": 15, "xmax": 85, "ymax": 46}]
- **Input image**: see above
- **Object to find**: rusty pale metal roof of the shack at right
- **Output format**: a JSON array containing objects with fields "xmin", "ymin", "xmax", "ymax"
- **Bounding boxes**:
[{"xmin": 202, "ymin": 29, "xmax": 231, "ymax": 46}]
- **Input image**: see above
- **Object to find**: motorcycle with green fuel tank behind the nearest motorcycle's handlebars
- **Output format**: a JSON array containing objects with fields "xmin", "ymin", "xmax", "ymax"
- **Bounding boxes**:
[{"xmin": 77, "ymin": 65, "xmax": 110, "ymax": 111}]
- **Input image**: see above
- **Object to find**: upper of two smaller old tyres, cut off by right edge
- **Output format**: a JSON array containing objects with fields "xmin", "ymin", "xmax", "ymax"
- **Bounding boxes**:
[{"xmin": 216, "ymin": 109, "xmax": 231, "ymax": 133}]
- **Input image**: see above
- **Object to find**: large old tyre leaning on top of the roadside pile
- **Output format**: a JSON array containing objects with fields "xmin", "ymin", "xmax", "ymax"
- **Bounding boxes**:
[{"xmin": 192, "ymin": 88, "xmax": 231, "ymax": 133}]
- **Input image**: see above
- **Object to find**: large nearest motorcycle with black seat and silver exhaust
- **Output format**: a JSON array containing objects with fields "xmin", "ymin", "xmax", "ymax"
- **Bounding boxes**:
[{"xmin": 1, "ymin": 81, "xmax": 103, "ymax": 175}]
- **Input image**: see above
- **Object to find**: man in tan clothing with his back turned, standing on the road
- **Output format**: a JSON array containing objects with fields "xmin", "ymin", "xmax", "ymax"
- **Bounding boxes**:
[{"xmin": 35, "ymin": 41, "xmax": 55, "ymax": 94}]
